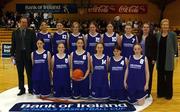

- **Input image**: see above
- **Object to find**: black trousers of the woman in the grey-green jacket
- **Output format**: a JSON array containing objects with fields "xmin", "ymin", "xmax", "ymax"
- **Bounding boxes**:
[{"xmin": 157, "ymin": 69, "xmax": 173, "ymax": 99}]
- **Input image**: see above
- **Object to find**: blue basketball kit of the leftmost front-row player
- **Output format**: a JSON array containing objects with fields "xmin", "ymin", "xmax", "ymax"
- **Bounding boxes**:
[{"xmin": 32, "ymin": 50, "xmax": 51, "ymax": 95}]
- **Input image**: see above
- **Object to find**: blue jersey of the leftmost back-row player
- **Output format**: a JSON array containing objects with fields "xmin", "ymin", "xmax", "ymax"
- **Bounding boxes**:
[{"xmin": 36, "ymin": 32, "xmax": 52, "ymax": 53}]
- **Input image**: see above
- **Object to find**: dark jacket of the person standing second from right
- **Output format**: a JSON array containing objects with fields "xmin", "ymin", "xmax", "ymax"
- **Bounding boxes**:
[{"xmin": 138, "ymin": 33, "xmax": 157, "ymax": 60}]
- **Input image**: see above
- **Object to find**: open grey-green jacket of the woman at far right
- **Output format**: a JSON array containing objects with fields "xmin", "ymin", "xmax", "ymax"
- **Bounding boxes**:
[{"xmin": 156, "ymin": 32, "xmax": 177, "ymax": 71}]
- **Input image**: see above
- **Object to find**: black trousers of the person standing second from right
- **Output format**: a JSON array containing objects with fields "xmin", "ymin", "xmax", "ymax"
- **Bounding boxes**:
[{"xmin": 148, "ymin": 59, "xmax": 154, "ymax": 94}]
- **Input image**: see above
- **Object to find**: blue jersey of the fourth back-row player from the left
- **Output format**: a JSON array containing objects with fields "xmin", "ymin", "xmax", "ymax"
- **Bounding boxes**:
[{"xmin": 86, "ymin": 33, "xmax": 101, "ymax": 55}]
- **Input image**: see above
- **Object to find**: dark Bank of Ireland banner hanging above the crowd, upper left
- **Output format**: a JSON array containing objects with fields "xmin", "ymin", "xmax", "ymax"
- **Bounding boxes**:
[{"xmin": 16, "ymin": 3, "xmax": 78, "ymax": 14}]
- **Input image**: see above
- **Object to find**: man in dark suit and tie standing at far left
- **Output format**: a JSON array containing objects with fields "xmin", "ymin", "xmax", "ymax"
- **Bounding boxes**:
[{"xmin": 11, "ymin": 17, "xmax": 36, "ymax": 96}]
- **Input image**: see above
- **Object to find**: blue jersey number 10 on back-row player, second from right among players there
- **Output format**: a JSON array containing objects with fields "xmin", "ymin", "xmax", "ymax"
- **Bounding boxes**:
[{"xmin": 103, "ymin": 33, "xmax": 117, "ymax": 57}]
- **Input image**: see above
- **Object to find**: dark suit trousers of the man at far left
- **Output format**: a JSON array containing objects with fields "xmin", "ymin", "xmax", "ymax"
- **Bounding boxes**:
[{"xmin": 16, "ymin": 51, "xmax": 32, "ymax": 91}]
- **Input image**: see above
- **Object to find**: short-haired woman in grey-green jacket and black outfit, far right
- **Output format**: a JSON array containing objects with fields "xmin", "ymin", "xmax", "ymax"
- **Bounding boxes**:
[{"xmin": 156, "ymin": 19, "xmax": 177, "ymax": 100}]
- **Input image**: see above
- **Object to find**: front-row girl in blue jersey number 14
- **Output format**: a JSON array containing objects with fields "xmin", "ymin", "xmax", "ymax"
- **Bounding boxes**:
[{"xmin": 91, "ymin": 43, "xmax": 109, "ymax": 99}]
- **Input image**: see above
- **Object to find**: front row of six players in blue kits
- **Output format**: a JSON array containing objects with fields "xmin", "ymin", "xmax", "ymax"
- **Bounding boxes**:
[{"xmin": 31, "ymin": 38, "xmax": 149, "ymax": 105}]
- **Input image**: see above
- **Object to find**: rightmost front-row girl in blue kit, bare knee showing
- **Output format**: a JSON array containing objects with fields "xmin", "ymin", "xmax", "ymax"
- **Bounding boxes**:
[{"xmin": 124, "ymin": 44, "xmax": 149, "ymax": 105}]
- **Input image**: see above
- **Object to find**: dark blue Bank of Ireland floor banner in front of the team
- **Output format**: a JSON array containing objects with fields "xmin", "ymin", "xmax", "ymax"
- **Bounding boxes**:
[{"xmin": 9, "ymin": 102, "xmax": 136, "ymax": 112}]
